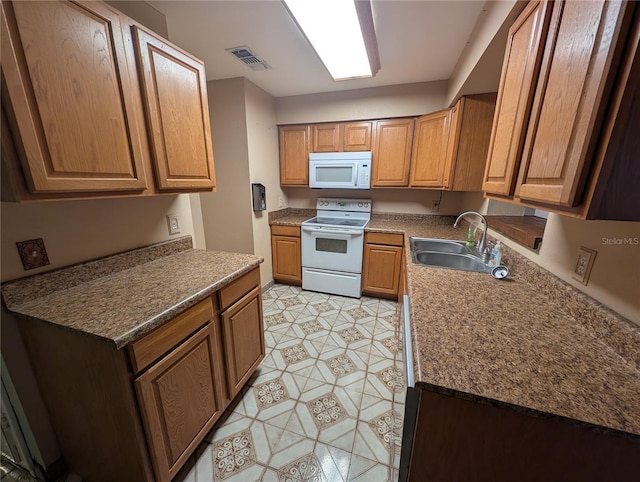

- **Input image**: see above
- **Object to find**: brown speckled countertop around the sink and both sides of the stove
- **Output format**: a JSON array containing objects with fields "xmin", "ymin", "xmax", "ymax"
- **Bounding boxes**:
[{"xmin": 270, "ymin": 210, "xmax": 640, "ymax": 435}]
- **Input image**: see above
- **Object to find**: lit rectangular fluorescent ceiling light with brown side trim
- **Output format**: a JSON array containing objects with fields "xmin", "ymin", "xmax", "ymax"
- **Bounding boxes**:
[{"xmin": 283, "ymin": 0, "xmax": 380, "ymax": 80}]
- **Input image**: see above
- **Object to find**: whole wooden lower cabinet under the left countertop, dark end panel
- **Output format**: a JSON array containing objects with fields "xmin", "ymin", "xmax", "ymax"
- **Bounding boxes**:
[{"xmin": 19, "ymin": 268, "xmax": 265, "ymax": 482}]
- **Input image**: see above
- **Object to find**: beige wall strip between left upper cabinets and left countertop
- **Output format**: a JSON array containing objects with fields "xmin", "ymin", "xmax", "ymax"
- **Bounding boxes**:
[{"xmin": 1, "ymin": 194, "xmax": 193, "ymax": 281}]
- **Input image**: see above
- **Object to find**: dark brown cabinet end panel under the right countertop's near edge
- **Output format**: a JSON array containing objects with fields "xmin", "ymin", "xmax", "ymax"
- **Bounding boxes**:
[{"xmin": 399, "ymin": 388, "xmax": 640, "ymax": 482}]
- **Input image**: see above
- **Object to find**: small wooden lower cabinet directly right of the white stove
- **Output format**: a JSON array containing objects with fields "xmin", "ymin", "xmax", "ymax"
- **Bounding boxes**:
[{"xmin": 362, "ymin": 233, "xmax": 404, "ymax": 299}]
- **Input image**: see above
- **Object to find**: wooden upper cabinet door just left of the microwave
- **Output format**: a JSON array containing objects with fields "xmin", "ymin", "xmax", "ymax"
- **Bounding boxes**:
[{"xmin": 279, "ymin": 125, "xmax": 310, "ymax": 186}]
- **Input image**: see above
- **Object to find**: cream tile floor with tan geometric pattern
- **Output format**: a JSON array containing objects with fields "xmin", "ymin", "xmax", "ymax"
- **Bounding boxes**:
[{"xmin": 175, "ymin": 284, "xmax": 405, "ymax": 482}]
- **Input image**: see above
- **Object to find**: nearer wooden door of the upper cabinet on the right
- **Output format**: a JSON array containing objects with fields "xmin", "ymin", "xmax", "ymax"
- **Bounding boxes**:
[{"xmin": 515, "ymin": 0, "xmax": 626, "ymax": 207}]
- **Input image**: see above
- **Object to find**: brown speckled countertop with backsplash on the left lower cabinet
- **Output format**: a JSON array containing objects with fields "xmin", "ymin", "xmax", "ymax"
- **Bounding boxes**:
[{"xmin": 2, "ymin": 236, "xmax": 263, "ymax": 348}]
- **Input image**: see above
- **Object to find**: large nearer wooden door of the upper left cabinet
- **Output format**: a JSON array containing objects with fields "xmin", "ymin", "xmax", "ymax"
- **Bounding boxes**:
[{"xmin": 2, "ymin": 1, "xmax": 147, "ymax": 193}]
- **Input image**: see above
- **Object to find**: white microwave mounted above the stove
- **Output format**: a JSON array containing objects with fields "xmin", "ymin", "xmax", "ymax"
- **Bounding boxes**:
[{"xmin": 309, "ymin": 151, "xmax": 371, "ymax": 189}]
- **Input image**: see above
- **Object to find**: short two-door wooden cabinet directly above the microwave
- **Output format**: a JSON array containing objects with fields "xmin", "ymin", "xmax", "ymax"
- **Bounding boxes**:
[{"xmin": 311, "ymin": 121, "xmax": 371, "ymax": 152}]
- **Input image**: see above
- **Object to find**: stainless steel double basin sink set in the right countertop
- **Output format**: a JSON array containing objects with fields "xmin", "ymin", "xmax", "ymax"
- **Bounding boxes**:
[{"xmin": 409, "ymin": 237, "xmax": 491, "ymax": 273}]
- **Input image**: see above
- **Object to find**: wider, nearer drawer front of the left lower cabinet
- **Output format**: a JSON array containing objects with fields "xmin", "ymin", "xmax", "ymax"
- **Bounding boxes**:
[{"xmin": 129, "ymin": 298, "xmax": 214, "ymax": 373}]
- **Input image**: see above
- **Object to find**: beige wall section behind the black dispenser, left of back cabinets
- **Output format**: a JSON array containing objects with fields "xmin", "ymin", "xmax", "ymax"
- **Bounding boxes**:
[{"xmin": 200, "ymin": 78, "xmax": 287, "ymax": 285}]
